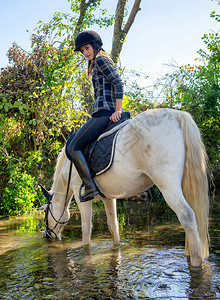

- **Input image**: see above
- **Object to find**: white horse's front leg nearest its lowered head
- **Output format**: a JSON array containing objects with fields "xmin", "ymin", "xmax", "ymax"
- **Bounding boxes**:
[{"xmin": 75, "ymin": 194, "xmax": 92, "ymax": 245}]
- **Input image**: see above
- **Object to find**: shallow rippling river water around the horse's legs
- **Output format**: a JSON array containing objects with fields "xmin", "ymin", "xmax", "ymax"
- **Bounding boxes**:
[{"xmin": 0, "ymin": 197, "xmax": 220, "ymax": 300}]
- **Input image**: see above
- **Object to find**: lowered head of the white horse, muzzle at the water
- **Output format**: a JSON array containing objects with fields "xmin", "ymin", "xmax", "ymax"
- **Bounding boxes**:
[{"xmin": 40, "ymin": 185, "xmax": 69, "ymax": 240}]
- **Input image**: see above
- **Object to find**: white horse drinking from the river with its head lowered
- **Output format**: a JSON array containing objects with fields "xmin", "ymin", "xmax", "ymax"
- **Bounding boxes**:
[{"xmin": 41, "ymin": 109, "xmax": 209, "ymax": 266}]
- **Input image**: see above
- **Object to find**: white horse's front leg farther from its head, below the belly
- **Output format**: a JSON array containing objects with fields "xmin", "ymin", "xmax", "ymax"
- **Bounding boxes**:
[{"xmin": 102, "ymin": 198, "xmax": 120, "ymax": 245}]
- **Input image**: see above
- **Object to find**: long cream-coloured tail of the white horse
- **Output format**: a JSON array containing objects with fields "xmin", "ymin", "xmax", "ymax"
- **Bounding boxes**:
[{"xmin": 178, "ymin": 112, "xmax": 209, "ymax": 258}]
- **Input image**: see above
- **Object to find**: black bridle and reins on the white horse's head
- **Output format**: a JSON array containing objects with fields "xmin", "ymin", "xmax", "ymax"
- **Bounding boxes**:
[{"xmin": 40, "ymin": 162, "xmax": 73, "ymax": 239}]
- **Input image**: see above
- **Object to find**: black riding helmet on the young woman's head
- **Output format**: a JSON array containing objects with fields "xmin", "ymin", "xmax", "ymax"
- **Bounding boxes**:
[{"xmin": 74, "ymin": 30, "xmax": 103, "ymax": 51}]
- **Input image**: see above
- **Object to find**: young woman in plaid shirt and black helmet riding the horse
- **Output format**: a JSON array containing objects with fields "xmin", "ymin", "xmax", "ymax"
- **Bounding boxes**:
[{"xmin": 67, "ymin": 30, "xmax": 123, "ymax": 202}]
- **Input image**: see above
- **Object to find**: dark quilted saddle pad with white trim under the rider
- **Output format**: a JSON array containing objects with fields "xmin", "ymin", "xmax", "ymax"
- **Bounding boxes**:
[{"xmin": 65, "ymin": 112, "xmax": 130, "ymax": 177}]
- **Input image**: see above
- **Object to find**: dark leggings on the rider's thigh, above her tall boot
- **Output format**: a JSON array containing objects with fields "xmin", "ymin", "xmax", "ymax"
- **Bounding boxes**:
[{"xmin": 67, "ymin": 116, "xmax": 110, "ymax": 153}]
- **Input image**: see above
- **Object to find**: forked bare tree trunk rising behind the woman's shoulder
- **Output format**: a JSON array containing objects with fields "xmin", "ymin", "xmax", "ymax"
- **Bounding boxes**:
[{"xmin": 111, "ymin": 0, "xmax": 141, "ymax": 63}]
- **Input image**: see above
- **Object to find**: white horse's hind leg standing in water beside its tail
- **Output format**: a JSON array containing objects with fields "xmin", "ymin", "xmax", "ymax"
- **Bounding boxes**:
[{"xmin": 160, "ymin": 185, "xmax": 202, "ymax": 266}]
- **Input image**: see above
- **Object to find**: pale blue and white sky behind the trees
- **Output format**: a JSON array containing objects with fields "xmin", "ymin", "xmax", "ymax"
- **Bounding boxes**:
[{"xmin": 0, "ymin": 0, "xmax": 220, "ymax": 83}]
